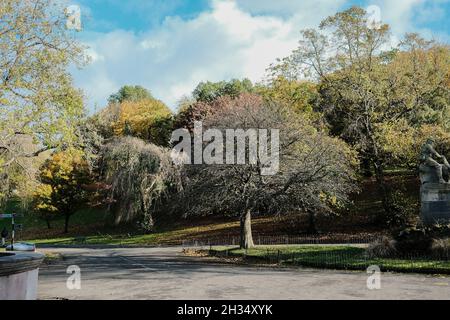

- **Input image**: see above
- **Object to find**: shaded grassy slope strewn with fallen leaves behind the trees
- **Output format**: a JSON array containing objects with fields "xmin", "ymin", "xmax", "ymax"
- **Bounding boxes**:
[{"xmin": 0, "ymin": 172, "xmax": 419, "ymax": 245}]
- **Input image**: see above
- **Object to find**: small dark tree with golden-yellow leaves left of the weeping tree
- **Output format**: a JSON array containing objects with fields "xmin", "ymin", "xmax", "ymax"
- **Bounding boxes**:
[{"xmin": 34, "ymin": 149, "xmax": 91, "ymax": 233}]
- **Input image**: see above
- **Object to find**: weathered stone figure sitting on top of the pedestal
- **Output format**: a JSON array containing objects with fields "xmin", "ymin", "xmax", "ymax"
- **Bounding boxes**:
[{"xmin": 419, "ymin": 138, "xmax": 450, "ymax": 185}]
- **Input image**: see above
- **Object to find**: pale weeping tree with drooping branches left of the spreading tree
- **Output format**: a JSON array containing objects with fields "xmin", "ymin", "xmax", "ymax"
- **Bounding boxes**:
[{"xmin": 100, "ymin": 137, "xmax": 180, "ymax": 231}]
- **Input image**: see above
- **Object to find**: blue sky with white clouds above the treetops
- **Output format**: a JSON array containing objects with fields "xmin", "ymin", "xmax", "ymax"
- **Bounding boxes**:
[{"xmin": 72, "ymin": 0, "xmax": 450, "ymax": 112}]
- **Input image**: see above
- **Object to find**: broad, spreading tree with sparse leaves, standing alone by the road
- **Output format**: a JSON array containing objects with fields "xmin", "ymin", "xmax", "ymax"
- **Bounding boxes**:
[{"xmin": 178, "ymin": 94, "xmax": 355, "ymax": 248}]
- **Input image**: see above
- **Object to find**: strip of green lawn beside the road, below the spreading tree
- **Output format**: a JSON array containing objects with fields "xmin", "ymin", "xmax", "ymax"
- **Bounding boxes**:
[{"xmin": 210, "ymin": 245, "xmax": 450, "ymax": 274}]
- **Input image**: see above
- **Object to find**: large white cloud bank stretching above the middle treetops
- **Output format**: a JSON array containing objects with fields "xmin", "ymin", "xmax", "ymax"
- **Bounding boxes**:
[{"xmin": 74, "ymin": 0, "xmax": 348, "ymax": 109}]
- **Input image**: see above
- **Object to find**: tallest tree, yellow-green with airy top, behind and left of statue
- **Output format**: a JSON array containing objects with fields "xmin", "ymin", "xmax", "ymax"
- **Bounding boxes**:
[{"xmin": 272, "ymin": 7, "xmax": 449, "ymax": 225}]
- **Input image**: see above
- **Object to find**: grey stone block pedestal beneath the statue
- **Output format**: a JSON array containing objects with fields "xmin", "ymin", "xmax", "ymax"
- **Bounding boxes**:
[{"xmin": 420, "ymin": 183, "xmax": 450, "ymax": 224}]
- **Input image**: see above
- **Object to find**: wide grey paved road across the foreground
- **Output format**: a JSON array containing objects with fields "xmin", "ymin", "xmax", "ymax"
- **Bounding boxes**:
[{"xmin": 38, "ymin": 247, "xmax": 450, "ymax": 299}]
